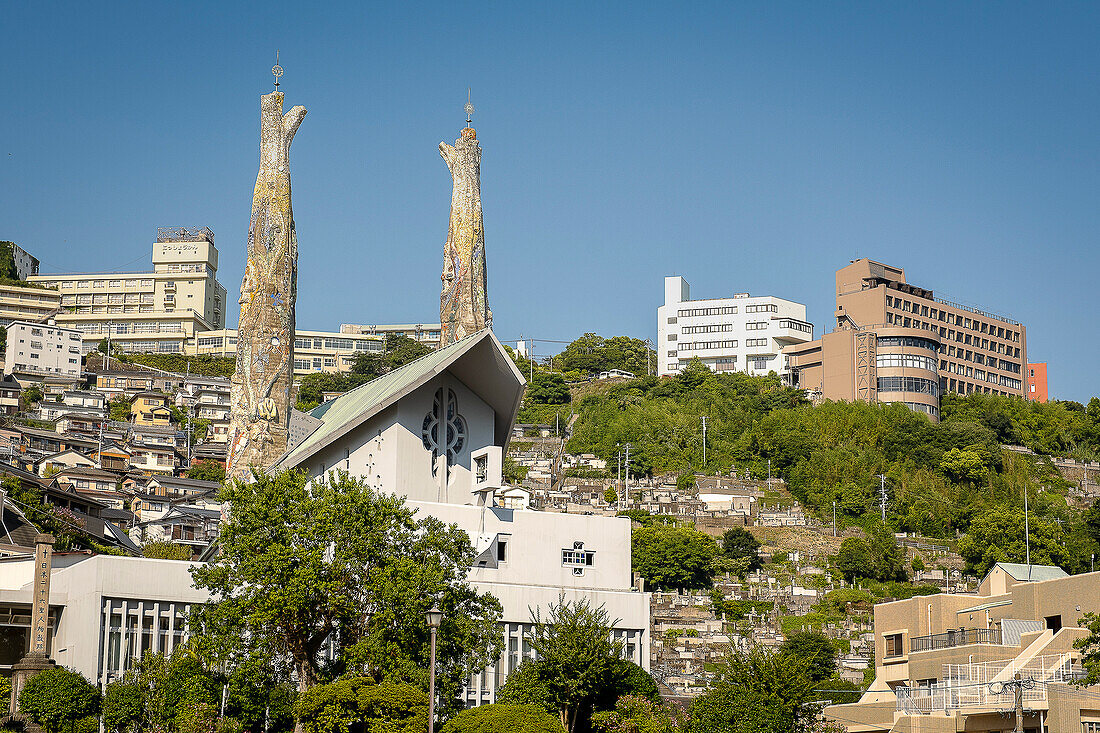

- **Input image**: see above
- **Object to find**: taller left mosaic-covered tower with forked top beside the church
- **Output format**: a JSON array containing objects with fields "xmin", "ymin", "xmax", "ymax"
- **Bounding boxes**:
[{"xmin": 226, "ymin": 79, "xmax": 306, "ymax": 479}]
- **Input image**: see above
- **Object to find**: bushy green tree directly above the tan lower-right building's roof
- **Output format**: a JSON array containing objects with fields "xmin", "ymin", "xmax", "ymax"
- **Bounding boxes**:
[{"xmin": 958, "ymin": 506, "xmax": 1075, "ymax": 578}]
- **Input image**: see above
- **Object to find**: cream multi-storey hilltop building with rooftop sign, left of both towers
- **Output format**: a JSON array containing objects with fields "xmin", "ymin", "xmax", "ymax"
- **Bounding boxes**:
[{"xmin": 30, "ymin": 227, "xmax": 227, "ymax": 353}]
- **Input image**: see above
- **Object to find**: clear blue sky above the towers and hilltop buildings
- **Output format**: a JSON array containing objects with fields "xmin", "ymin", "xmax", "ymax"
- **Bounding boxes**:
[{"xmin": 0, "ymin": 2, "xmax": 1100, "ymax": 401}]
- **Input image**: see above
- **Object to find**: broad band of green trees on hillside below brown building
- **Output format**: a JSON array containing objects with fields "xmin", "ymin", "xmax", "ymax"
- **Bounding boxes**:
[{"xmin": 543, "ymin": 356, "xmax": 1100, "ymax": 571}]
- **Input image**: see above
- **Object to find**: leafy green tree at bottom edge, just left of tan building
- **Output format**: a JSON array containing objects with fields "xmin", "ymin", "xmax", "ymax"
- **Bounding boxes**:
[{"xmin": 691, "ymin": 646, "xmax": 817, "ymax": 733}]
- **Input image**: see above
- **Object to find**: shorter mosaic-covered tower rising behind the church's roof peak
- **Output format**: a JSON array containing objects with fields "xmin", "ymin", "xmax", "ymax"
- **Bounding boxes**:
[{"xmin": 439, "ymin": 93, "xmax": 493, "ymax": 347}]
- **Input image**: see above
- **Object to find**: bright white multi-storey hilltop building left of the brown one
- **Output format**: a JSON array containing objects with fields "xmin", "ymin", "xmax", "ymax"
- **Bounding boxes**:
[{"xmin": 657, "ymin": 276, "xmax": 814, "ymax": 376}]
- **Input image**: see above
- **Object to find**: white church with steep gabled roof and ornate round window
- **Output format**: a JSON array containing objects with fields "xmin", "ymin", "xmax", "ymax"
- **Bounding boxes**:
[{"xmin": 276, "ymin": 330, "xmax": 650, "ymax": 705}]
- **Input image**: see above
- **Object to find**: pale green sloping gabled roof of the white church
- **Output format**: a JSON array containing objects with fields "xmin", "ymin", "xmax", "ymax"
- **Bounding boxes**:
[{"xmin": 273, "ymin": 329, "xmax": 525, "ymax": 469}]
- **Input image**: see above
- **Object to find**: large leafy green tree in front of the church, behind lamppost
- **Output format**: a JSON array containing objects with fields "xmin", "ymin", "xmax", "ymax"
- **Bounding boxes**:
[{"xmin": 191, "ymin": 471, "xmax": 502, "ymax": 709}]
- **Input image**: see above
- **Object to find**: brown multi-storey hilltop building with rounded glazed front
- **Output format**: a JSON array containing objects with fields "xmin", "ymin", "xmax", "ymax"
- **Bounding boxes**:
[{"xmin": 783, "ymin": 259, "xmax": 1027, "ymax": 419}]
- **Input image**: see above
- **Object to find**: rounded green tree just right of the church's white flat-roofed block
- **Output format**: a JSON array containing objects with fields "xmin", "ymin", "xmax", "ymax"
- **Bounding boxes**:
[{"xmin": 630, "ymin": 524, "xmax": 719, "ymax": 590}]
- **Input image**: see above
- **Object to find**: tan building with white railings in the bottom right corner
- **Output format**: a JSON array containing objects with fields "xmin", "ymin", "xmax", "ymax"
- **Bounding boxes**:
[{"xmin": 825, "ymin": 562, "xmax": 1100, "ymax": 733}]
